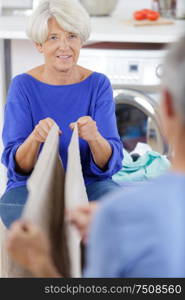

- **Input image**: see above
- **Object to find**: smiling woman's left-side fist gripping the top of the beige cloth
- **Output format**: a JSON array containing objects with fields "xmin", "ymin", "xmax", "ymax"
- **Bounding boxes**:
[{"xmin": 30, "ymin": 118, "xmax": 62, "ymax": 143}]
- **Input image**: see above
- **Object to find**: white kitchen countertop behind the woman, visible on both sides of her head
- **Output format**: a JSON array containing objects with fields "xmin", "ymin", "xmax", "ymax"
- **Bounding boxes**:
[{"xmin": 0, "ymin": 16, "xmax": 185, "ymax": 43}]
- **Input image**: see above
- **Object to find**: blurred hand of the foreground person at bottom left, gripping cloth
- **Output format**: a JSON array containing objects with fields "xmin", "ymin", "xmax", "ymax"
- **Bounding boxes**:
[{"xmin": 6, "ymin": 220, "xmax": 61, "ymax": 277}]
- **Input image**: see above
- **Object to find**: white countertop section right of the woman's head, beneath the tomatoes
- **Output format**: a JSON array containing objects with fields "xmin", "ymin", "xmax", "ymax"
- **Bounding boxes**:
[{"xmin": 91, "ymin": 17, "xmax": 185, "ymax": 43}]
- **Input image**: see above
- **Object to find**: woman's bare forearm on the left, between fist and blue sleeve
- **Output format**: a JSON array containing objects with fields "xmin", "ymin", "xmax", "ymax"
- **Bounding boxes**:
[{"xmin": 15, "ymin": 134, "xmax": 41, "ymax": 173}]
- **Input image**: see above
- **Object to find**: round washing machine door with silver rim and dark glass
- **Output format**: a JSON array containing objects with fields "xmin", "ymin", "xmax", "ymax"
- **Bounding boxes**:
[{"xmin": 114, "ymin": 89, "xmax": 167, "ymax": 154}]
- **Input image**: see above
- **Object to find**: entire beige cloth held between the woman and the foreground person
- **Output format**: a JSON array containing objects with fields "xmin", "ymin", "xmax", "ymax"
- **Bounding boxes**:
[{"xmin": 2, "ymin": 125, "xmax": 88, "ymax": 277}]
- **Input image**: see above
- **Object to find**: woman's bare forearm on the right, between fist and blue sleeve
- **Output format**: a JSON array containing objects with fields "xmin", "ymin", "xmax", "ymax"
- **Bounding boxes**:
[{"xmin": 89, "ymin": 134, "xmax": 112, "ymax": 169}]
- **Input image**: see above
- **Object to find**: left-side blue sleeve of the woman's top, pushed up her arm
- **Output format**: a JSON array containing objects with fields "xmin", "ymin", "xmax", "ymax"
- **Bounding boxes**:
[{"xmin": 1, "ymin": 76, "xmax": 33, "ymax": 182}]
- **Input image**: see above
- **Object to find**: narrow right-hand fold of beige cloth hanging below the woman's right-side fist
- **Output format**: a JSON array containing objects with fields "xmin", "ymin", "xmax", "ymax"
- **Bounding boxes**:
[{"xmin": 65, "ymin": 124, "xmax": 88, "ymax": 277}]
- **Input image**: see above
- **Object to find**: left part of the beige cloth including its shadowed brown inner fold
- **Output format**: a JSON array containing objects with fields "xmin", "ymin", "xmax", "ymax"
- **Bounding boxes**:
[{"xmin": 2, "ymin": 125, "xmax": 70, "ymax": 277}]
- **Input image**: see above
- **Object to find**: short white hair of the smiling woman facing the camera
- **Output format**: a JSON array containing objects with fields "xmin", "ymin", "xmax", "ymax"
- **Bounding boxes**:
[{"xmin": 26, "ymin": 0, "xmax": 91, "ymax": 44}]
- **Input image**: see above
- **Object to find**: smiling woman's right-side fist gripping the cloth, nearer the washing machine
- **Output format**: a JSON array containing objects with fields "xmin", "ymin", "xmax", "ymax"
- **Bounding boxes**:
[{"xmin": 70, "ymin": 116, "xmax": 100, "ymax": 143}]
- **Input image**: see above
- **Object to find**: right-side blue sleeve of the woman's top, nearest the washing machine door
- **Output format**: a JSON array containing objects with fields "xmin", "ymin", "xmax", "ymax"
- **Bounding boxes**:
[{"xmin": 90, "ymin": 77, "xmax": 123, "ymax": 179}]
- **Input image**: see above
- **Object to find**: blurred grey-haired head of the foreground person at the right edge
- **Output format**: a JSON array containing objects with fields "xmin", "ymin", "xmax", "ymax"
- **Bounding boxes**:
[{"xmin": 162, "ymin": 36, "xmax": 185, "ymax": 123}]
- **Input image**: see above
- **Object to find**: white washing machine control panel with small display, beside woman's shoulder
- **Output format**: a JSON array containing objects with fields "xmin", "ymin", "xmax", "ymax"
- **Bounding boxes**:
[{"xmin": 79, "ymin": 48, "xmax": 166, "ymax": 86}]
